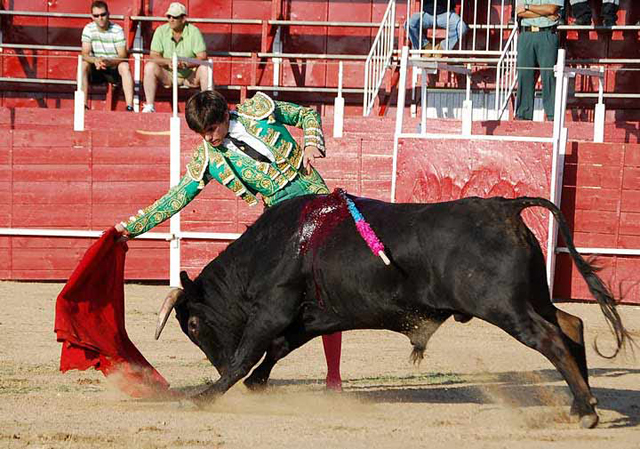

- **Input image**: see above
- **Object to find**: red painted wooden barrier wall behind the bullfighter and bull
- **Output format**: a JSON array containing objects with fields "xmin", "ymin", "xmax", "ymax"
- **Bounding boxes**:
[{"xmin": 0, "ymin": 108, "xmax": 640, "ymax": 303}]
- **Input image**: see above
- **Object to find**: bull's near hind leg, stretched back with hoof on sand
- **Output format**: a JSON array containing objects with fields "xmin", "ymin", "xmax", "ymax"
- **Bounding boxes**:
[{"xmin": 493, "ymin": 309, "xmax": 598, "ymax": 428}]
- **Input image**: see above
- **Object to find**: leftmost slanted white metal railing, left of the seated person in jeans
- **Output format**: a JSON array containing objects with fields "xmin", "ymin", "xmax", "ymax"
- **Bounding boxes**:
[{"xmin": 362, "ymin": 0, "xmax": 396, "ymax": 117}]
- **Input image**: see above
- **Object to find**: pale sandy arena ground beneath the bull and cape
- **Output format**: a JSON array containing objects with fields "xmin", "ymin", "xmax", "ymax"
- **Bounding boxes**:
[{"xmin": 0, "ymin": 282, "xmax": 640, "ymax": 449}]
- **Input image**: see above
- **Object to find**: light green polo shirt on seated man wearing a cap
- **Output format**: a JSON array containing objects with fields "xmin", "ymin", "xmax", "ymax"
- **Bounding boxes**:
[{"xmin": 151, "ymin": 23, "xmax": 207, "ymax": 78}]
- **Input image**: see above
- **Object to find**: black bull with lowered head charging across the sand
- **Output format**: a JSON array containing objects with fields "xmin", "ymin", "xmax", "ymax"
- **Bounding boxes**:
[{"xmin": 156, "ymin": 195, "xmax": 629, "ymax": 427}]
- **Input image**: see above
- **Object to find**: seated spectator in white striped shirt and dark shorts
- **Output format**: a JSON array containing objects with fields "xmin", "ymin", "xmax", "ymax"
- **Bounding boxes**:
[{"xmin": 82, "ymin": 0, "xmax": 133, "ymax": 111}]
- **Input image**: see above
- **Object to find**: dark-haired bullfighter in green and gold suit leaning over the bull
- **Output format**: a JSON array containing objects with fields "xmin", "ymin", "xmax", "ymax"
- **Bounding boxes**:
[{"xmin": 116, "ymin": 91, "xmax": 342, "ymax": 390}]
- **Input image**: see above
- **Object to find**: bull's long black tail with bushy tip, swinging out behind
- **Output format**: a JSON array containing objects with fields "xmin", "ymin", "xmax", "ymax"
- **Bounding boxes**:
[{"xmin": 514, "ymin": 197, "xmax": 633, "ymax": 358}]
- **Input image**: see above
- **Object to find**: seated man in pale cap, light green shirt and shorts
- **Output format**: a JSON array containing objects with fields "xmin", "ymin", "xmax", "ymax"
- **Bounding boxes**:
[{"xmin": 142, "ymin": 2, "xmax": 208, "ymax": 112}]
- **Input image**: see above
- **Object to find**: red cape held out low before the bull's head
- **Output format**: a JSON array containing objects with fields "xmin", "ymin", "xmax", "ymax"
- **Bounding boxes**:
[{"xmin": 54, "ymin": 228, "xmax": 169, "ymax": 397}]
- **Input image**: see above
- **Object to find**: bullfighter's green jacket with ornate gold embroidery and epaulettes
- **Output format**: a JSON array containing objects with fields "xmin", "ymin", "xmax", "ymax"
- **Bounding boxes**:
[{"xmin": 123, "ymin": 92, "xmax": 328, "ymax": 237}]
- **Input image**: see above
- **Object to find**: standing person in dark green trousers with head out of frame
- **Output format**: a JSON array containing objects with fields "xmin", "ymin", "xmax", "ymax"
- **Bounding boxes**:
[{"xmin": 516, "ymin": 0, "xmax": 564, "ymax": 120}]
